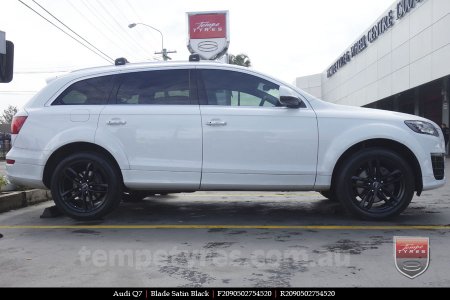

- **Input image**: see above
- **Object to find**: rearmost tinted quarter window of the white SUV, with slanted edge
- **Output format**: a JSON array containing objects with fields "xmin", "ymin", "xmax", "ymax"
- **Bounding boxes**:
[{"xmin": 52, "ymin": 75, "xmax": 114, "ymax": 105}]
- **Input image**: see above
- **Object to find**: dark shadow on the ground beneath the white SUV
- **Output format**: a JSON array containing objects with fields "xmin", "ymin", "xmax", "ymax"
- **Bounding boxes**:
[{"xmin": 59, "ymin": 195, "xmax": 437, "ymax": 226}]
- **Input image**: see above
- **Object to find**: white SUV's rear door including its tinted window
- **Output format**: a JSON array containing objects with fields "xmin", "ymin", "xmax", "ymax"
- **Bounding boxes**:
[{"xmin": 96, "ymin": 69, "xmax": 202, "ymax": 190}]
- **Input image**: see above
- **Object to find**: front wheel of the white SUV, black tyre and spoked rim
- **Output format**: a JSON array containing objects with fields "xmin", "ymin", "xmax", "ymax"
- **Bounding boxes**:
[{"xmin": 335, "ymin": 148, "xmax": 415, "ymax": 220}]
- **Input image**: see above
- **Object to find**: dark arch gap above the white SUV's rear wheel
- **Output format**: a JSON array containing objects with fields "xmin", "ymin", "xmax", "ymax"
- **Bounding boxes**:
[{"xmin": 42, "ymin": 142, "xmax": 123, "ymax": 188}]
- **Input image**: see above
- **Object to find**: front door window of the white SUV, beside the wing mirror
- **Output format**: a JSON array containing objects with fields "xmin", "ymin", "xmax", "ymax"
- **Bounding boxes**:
[{"xmin": 201, "ymin": 70, "xmax": 281, "ymax": 107}]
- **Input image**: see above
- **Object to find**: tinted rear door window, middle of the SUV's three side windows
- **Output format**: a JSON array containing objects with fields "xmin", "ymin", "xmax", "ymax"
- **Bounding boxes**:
[{"xmin": 116, "ymin": 70, "xmax": 191, "ymax": 105}]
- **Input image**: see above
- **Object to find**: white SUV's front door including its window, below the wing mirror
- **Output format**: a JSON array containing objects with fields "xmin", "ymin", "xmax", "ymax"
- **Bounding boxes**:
[{"xmin": 198, "ymin": 68, "xmax": 318, "ymax": 190}]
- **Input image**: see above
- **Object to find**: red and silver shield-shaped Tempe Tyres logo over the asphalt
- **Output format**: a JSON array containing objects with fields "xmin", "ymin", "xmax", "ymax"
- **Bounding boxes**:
[{"xmin": 394, "ymin": 236, "xmax": 430, "ymax": 279}]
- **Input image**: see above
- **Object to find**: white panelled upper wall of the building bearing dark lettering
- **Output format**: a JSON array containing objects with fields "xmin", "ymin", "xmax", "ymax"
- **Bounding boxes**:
[{"xmin": 296, "ymin": 0, "xmax": 450, "ymax": 106}]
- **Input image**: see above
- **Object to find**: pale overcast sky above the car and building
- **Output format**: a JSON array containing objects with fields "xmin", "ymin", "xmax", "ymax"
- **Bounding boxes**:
[{"xmin": 0, "ymin": 0, "xmax": 394, "ymax": 114}]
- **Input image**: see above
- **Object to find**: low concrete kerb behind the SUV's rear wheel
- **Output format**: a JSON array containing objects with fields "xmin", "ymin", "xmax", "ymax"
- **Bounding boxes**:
[{"xmin": 0, "ymin": 189, "xmax": 52, "ymax": 213}]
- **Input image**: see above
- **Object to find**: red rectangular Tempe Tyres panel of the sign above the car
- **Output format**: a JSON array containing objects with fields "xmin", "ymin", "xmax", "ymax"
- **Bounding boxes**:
[{"xmin": 189, "ymin": 14, "xmax": 227, "ymax": 39}]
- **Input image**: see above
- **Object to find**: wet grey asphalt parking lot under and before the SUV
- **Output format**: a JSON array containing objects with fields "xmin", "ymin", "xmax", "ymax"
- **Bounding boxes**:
[{"xmin": 0, "ymin": 160, "xmax": 450, "ymax": 287}]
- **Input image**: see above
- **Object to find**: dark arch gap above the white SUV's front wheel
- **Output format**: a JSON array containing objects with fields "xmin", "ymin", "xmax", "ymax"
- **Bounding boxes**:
[{"xmin": 331, "ymin": 139, "xmax": 423, "ymax": 196}]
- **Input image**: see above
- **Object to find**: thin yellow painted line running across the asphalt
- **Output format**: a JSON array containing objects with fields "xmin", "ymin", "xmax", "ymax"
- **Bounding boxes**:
[{"xmin": 0, "ymin": 224, "xmax": 450, "ymax": 230}]
